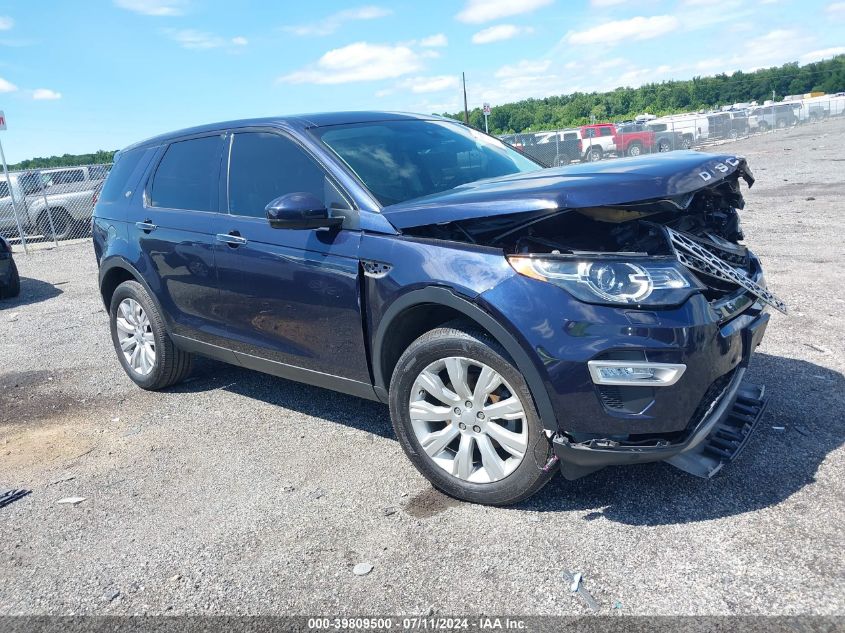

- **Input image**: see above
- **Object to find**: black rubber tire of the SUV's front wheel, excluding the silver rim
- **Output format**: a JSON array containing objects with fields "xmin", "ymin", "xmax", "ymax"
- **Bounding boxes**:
[{"xmin": 389, "ymin": 322, "xmax": 555, "ymax": 506}]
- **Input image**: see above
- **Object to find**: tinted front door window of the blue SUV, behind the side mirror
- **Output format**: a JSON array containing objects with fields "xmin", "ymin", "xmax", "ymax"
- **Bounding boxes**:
[{"xmin": 228, "ymin": 132, "xmax": 348, "ymax": 217}]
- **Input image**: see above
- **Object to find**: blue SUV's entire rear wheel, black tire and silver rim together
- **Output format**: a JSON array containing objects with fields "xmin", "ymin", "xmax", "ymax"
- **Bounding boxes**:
[{"xmin": 109, "ymin": 281, "xmax": 193, "ymax": 391}]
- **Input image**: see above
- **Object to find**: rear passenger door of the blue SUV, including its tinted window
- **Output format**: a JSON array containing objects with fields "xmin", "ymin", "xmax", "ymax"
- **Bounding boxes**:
[{"xmin": 128, "ymin": 133, "xmax": 225, "ymax": 345}]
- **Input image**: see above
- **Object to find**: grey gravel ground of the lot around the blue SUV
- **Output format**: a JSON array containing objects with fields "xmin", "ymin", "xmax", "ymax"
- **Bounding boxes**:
[{"xmin": 0, "ymin": 116, "xmax": 845, "ymax": 615}]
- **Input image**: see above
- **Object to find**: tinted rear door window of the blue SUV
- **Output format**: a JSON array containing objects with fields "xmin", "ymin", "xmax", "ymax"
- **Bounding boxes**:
[{"xmin": 150, "ymin": 136, "xmax": 221, "ymax": 211}]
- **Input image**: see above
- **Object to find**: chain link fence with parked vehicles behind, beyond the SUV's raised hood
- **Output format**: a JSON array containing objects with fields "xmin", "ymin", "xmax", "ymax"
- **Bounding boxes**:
[{"xmin": 500, "ymin": 93, "xmax": 845, "ymax": 167}]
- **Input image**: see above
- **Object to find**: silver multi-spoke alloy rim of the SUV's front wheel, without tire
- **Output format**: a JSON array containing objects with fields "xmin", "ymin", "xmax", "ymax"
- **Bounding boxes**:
[{"xmin": 408, "ymin": 356, "xmax": 528, "ymax": 483}]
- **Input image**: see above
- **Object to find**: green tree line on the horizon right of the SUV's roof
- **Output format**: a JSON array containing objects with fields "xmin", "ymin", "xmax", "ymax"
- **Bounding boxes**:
[{"xmin": 442, "ymin": 55, "xmax": 845, "ymax": 134}]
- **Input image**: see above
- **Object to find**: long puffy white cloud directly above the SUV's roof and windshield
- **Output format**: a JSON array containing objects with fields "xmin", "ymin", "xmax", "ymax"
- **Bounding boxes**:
[{"xmin": 279, "ymin": 42, "xmax": 422, "ymax": 84}]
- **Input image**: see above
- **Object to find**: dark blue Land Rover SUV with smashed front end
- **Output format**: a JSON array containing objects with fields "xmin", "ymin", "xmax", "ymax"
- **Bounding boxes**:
[{"xmin": 93, "ymin": 112, "xmax": 785, "ymax": 505}]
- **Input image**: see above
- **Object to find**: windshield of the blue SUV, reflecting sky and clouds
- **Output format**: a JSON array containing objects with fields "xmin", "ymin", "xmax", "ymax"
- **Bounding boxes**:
[{"xmin": 312, "ymin": 120, "xmax": 542, "ymax": 206}]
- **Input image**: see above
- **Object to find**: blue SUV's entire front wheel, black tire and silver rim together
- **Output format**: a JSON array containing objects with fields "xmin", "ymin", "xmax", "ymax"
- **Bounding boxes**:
[{"xmin": 389, "ymin": 323, "xmax": 554, "ymax": 506}]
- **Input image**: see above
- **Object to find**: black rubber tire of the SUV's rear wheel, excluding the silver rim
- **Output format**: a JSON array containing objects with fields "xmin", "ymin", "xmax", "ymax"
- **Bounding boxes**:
[{"xmin": 109, "ymin": 281, "xmax": 193, "ymax": 391}]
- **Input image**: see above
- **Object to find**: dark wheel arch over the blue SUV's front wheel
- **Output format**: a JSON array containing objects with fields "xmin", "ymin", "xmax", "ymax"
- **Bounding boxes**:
[{"xmin": 372, "ymin": 288, "xmax": 558, "ymax": 432}]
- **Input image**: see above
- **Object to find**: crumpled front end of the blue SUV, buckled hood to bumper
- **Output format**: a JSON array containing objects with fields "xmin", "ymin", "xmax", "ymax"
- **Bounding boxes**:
[{"xmin": 385, "ymin": 152, "xmax": 786, "ymax": 479}]
